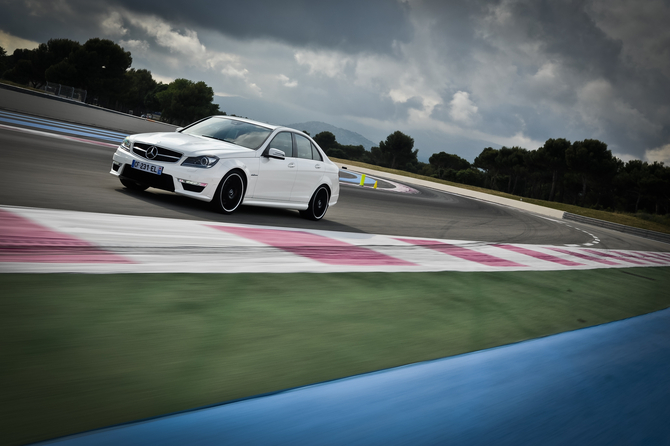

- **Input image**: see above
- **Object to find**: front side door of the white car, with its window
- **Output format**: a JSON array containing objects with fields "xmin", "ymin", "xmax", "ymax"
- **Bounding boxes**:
[{"xmin": 253, "ymin": 132, "xmax": 298, "ymax": 201}]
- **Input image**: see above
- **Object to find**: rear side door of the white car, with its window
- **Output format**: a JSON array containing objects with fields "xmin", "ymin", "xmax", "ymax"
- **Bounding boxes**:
[{"xmin": 291, "ymin": 133, "xmax": 324, "ymax": 203}]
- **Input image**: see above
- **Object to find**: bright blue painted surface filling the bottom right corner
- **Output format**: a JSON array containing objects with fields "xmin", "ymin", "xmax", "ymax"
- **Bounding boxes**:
[{"xmin": 43, "ymin": 309, "xmax": 670, "ymax": 445}]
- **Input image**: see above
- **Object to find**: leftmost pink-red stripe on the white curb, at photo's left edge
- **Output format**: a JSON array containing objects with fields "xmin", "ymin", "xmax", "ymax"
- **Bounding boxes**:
[{"xmin": 0, "ymin": 209, "xmax": 134, "ymax": 263}]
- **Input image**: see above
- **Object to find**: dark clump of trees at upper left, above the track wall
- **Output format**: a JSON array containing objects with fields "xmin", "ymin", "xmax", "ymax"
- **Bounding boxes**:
[{"xmin": 0, "ymin": 38, "xmax": 220, "ymax": 125}]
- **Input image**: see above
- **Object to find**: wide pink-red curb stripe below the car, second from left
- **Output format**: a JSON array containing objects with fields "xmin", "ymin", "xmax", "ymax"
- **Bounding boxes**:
[{"xmin": 213, "ymin": 225, "xmax": 415, "ymax": 266}]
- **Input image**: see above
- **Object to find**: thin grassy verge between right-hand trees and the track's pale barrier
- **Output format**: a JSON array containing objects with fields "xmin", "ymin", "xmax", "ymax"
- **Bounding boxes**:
[{"xmin": 331, "ymin": 158, "xmax": 670, "ymax": 234}]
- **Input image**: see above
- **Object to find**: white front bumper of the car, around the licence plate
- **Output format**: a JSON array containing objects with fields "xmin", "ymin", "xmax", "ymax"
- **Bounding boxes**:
[{"xmin": 109, "ymin": 148, "xmax": 220, "ymax": 201}]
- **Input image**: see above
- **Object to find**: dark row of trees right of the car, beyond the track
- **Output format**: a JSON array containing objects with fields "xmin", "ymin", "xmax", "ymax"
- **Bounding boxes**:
[{"xmin": 314, "ymin": 131, "xmax": 670, "ymax": 215}]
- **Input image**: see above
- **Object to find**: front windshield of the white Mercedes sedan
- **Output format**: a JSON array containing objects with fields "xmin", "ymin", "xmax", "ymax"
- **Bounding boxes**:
[{"xmin": 182, "ymin": 118, "xmax": 272, "ymax": 150}]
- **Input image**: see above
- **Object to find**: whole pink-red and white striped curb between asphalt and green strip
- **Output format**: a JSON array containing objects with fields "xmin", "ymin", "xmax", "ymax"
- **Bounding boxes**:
[{"xmin": 0, "ymin": 206, "xmax": 670, "ymax": 273}]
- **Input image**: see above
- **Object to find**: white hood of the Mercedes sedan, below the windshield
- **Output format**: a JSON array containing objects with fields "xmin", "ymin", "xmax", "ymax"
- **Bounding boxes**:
[{"xmin": 130, "ymin": 132, "xmax": 254, "ymax": 156}]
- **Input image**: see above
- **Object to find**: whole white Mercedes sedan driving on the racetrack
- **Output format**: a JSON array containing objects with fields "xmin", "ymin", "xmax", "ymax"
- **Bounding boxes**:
[{"xmin": 110, "ymin": 116, "xmax": 340, "ymax": 220}]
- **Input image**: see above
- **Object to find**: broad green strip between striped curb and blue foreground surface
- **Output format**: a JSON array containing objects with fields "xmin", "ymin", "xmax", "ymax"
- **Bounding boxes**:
[{"xmin": 0, "ymin": 267, "xmax": 670, "ymax": 444}]
